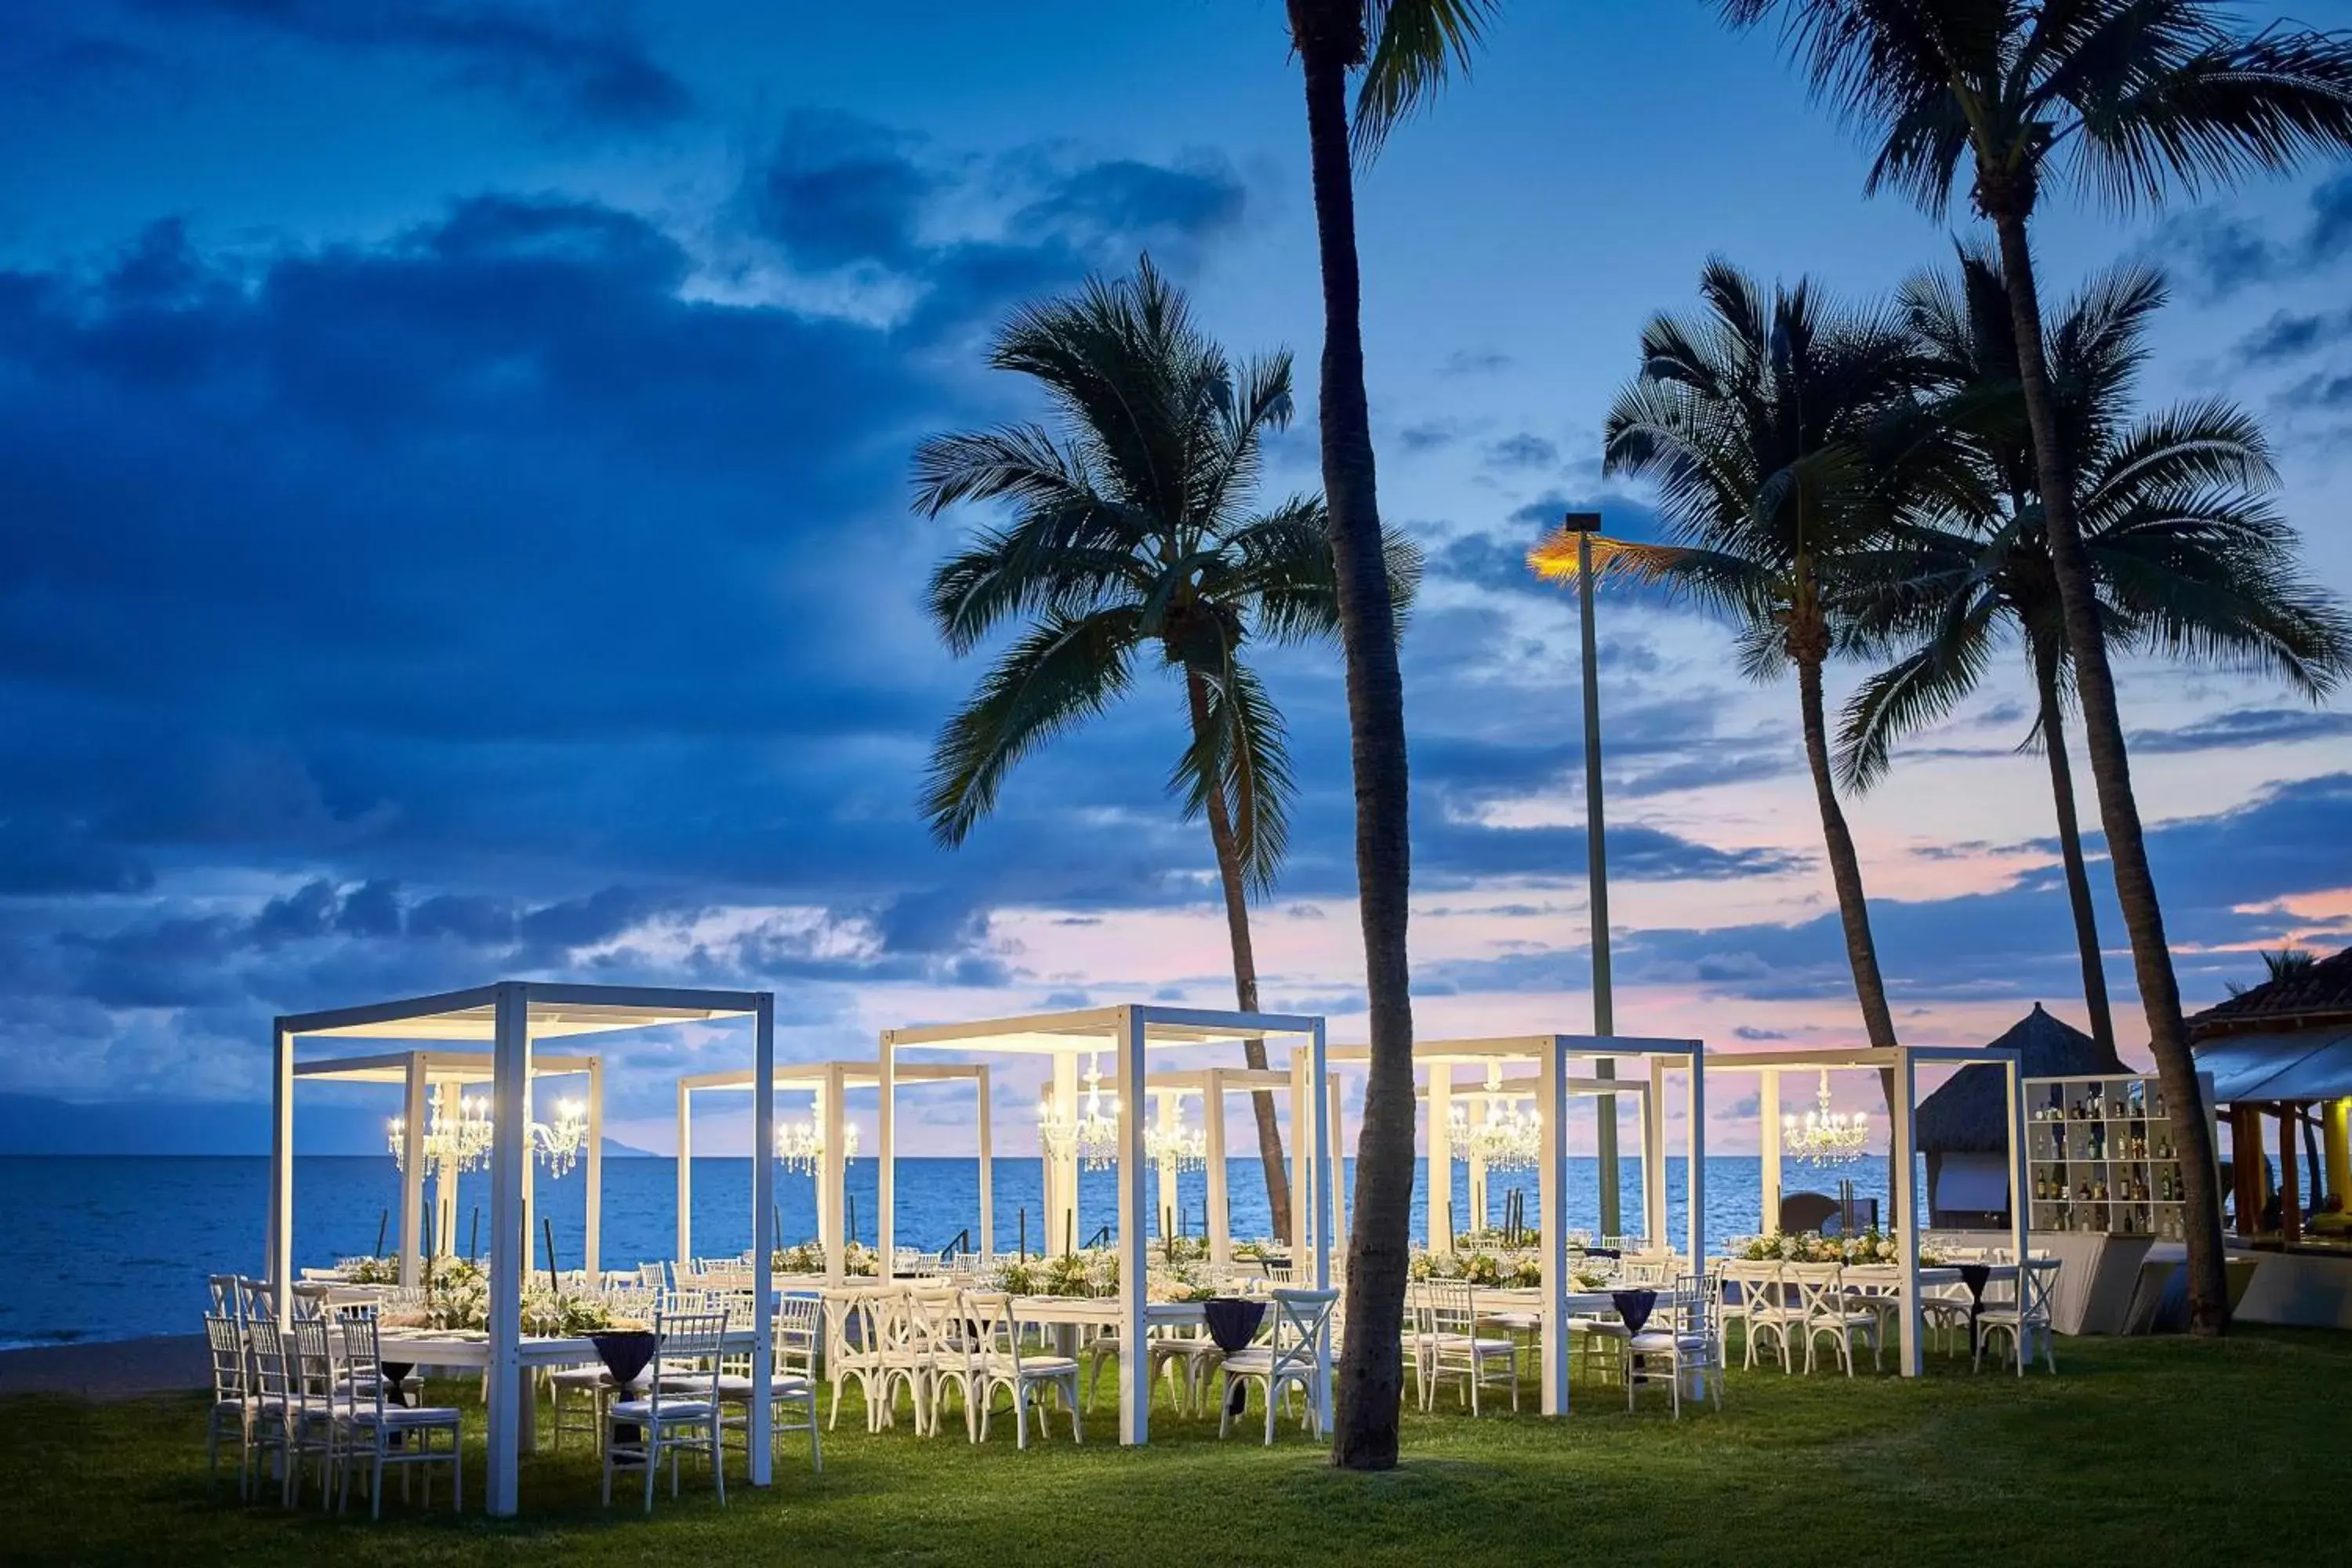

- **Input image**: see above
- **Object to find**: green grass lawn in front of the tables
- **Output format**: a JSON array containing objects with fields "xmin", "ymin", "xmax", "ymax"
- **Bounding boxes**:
[{"xmin": 0, "ymin": 1330, "xmax": 2352, "ymax": 1568}]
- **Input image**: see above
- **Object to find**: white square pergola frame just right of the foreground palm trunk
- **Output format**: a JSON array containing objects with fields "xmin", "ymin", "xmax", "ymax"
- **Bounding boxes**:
[{"xmin": 1331, "ymin": 1034, "xmax": 1724, "ymax": 1415}]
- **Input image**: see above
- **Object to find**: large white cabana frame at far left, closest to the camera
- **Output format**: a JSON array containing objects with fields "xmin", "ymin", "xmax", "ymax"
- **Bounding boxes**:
[{"xmin": 268, "ymin": 980, "xmax": 776, "ymax": 1516}]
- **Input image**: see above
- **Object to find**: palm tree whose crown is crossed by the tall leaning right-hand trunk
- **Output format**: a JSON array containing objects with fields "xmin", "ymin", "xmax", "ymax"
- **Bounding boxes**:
[{"xmin": 1839, "ymin": 249, "xmax": 2352, "ymax": 1051}]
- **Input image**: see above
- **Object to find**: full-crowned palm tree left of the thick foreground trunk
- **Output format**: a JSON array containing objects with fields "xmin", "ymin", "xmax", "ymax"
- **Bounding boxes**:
[{"xmin": 915, "ymin": 256, "xmax": 1421, "ymax": 1234}]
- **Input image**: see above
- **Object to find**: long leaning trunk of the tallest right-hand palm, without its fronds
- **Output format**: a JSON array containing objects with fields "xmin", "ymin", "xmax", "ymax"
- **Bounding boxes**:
[{"xmin": 1994, "ymin": 207, "xmax": 2230, "ymax": 1333}]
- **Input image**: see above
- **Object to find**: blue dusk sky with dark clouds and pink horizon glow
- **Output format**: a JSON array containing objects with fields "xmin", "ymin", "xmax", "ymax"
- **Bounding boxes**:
[{"xmin": 0, "ymin": 0, "xmax": 2352, "ymax": 1149}]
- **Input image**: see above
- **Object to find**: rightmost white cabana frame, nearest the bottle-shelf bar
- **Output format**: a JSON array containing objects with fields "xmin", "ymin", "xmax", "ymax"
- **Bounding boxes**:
[{"xmin": 1710, "ymin": 1046, "xmax": 2027, "ymax": 1377}]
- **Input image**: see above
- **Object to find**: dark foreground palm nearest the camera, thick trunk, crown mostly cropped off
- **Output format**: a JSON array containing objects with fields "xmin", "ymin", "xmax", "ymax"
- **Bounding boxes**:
[{"xmin": 1287, "ymin": 0, "xmax": 1494, "ymax": 1469}]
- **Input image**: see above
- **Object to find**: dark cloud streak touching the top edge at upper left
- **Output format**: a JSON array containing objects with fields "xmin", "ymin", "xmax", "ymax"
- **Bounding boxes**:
[{"xmin": 134, "ymin": 0, "xmax": 694, "ymax": 129}]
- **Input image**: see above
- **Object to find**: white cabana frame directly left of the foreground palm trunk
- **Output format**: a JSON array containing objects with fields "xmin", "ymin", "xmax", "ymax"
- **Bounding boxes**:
[{"xmin": 877, "ymin": 1006, "xmax": 1331, "ymax": 1443}]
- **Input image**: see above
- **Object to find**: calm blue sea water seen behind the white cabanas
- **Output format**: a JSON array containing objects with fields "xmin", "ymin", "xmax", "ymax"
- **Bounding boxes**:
[{"xmin": 0, "ymin": 1156, "xmax": 1886, "ymax": 1345}]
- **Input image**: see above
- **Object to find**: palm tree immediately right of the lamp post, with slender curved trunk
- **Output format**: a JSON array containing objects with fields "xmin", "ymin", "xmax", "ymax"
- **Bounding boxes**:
[{"xmin": 1562, "ymin": 261, "xmax": 1938, "ymax": 1062}]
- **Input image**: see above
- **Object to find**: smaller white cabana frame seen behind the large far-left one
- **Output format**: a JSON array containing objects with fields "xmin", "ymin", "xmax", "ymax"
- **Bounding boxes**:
[{"xmin": 294, "ymin": 1048, "xmax": 604, "ymax": 1286}]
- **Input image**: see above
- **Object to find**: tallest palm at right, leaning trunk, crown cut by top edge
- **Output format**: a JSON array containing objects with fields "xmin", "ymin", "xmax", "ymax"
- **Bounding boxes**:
[{"xmin": 1717, "ymin": 0, "xmax": 2352, "ymax": 1333}]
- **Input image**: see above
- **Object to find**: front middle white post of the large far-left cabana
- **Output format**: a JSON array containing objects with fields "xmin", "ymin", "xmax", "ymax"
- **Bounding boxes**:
[{"xmin": 485, "ymin": 980, "xmax": 532, "ymax": 1519}]
